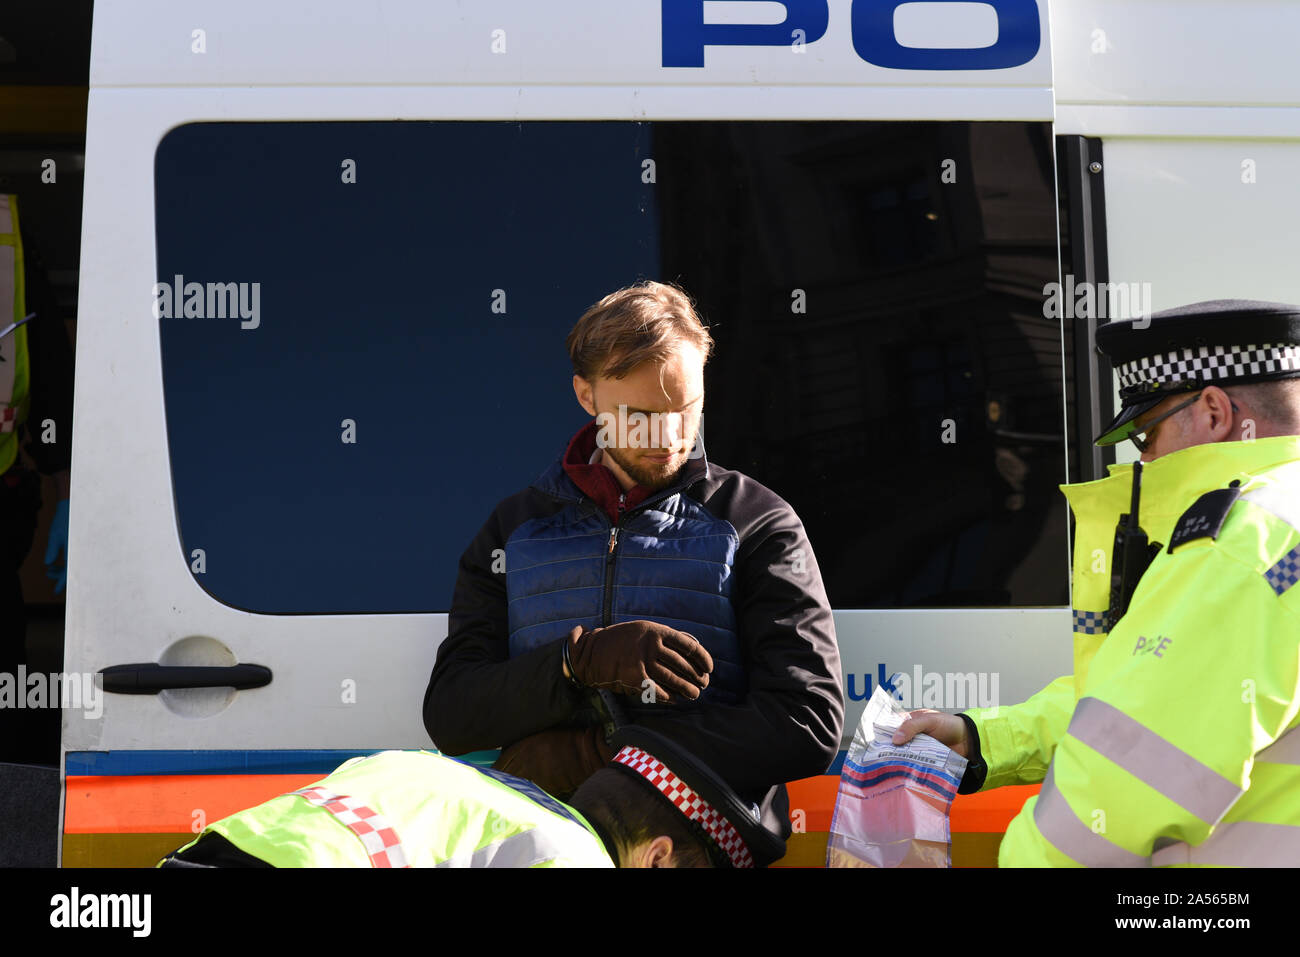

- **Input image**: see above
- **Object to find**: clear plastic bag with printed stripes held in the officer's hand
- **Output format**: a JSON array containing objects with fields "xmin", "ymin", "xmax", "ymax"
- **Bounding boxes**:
[{"xmin": 826, "ymin": 679, "xmax": 966, "ymax": 867}]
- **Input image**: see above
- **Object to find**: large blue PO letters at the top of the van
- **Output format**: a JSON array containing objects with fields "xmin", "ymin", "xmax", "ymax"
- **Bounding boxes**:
[{"xmin": 660, "ymin": 0, "xmax": 1043, "ymax": 70}]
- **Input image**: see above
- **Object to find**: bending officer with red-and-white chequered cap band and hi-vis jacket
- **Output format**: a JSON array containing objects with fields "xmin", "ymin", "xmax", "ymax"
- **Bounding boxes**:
[{"xmin": 160, "ymin": 727, "xmax": 785, "ymax": 867}]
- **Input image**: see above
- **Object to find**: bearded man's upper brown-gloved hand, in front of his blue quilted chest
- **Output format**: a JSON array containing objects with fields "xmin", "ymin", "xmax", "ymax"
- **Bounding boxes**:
[{"xmin": 568, "ymin": 622, "xmax": 714, "ymax": 701}]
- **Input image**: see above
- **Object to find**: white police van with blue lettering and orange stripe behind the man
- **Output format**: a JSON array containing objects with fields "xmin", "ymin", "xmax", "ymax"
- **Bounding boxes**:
[{"xmin": 61, "ymin": 0, "xmax": 1300, "ymax": 865}]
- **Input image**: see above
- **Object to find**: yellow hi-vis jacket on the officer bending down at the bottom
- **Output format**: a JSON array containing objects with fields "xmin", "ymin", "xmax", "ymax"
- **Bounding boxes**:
[{"xmin": 166, "ymin": 752, "xmax": 614, "ymax": 867}]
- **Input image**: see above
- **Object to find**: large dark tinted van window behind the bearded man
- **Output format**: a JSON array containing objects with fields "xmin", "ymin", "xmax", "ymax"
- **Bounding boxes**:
[{"xmin": 152, "ymin": 122, "xmax": 1066, "ymax": 614}]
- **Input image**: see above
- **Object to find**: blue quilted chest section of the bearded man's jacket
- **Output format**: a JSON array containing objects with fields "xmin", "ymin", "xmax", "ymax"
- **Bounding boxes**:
[{"xmin": 506, "ymin": 462, "xmax": 748, "ymax": 705}]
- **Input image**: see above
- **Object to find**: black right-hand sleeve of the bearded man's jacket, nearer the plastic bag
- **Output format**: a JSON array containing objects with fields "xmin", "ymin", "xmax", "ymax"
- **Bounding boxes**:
[{"xmin": 637, "ymin": 476, "xmax": 844, "ymax": 794}]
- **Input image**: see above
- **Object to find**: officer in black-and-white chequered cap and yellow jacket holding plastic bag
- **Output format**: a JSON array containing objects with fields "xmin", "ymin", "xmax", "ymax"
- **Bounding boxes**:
[{"xmin": 894, "ymin": 300, "xmax": 1300, "ymax": 867}]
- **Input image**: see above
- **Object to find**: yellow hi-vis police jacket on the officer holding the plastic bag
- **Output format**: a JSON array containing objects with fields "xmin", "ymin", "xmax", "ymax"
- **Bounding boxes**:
[{"xmin": 967, "ymin": 436, "xmax": 1300, "ymax": 867}]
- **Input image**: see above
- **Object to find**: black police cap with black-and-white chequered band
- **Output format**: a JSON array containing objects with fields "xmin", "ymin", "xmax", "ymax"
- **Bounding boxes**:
[{"xmin": 1097, "ymin": 299, "xmax": 1300, "ymax": 445}]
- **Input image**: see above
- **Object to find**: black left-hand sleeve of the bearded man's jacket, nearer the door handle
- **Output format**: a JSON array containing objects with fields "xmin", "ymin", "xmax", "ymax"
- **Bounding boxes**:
[{"xmin": 424, "ymin": 492, "xmax": 584, "ymax": 754}]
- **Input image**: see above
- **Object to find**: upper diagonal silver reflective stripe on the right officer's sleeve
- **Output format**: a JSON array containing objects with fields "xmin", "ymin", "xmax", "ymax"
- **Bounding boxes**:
[{"xmin": 1069, "ymin": 698, "xmax": 1244, "ymax": 824}]
